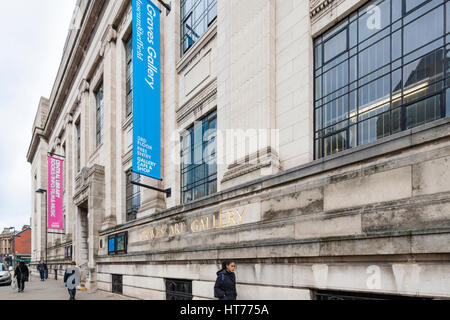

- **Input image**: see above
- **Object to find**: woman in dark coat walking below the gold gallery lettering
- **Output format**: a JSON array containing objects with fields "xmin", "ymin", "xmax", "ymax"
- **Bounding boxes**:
[{"xmin": 214, "ymin": 260, "xmax": 237, "ymax": 300}]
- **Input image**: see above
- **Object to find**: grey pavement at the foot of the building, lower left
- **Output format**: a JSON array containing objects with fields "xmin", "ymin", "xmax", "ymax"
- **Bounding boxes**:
[{"xmin": 0, "ymin": 276, "xmax": 131, "ymax": 300}]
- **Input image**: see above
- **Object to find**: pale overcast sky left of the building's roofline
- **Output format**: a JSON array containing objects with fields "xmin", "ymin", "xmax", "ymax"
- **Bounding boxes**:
[{"xmin": 0, "ymin": 0, "xmax": 76, "ymax": 233}]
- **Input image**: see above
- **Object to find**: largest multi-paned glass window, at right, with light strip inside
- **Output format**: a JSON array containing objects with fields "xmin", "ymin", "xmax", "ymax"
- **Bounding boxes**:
[{"xmin": 314, "ymin": 0, "xmax": 450, "ymax": 158}]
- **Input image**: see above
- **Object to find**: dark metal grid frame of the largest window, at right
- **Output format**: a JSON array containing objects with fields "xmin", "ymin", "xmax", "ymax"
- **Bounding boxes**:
[{"xmin": 313, "ymin": 0, "xmax": 450, "ymax": 159}]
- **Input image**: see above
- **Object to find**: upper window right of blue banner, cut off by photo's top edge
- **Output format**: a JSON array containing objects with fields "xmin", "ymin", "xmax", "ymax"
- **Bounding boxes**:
[{"xmin": 181, "ymin": 0, "xmax": 217, "ymax": 55}]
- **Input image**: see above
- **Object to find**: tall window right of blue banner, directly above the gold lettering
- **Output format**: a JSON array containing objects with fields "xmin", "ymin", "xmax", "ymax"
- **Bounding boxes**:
[{"xmin": 181, "ymin": 112, "xmax": 217, "ymax": 203}]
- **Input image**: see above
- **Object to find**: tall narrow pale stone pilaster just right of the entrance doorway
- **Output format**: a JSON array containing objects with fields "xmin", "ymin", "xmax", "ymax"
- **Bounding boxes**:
[{"xmin": 100, "ymin": 25, "xmax": 120, "ymax": 229}]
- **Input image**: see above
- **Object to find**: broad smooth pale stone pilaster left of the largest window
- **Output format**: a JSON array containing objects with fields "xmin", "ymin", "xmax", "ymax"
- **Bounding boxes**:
[{"xmin": 217, "ymin": 0, "xmax": 280, "ymax": 190}]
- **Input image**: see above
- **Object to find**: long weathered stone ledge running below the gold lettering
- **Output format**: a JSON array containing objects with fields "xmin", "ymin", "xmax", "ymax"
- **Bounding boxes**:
[{"xmin": 97, "ymin": 228, "xmax": 450, "ymax": 263}]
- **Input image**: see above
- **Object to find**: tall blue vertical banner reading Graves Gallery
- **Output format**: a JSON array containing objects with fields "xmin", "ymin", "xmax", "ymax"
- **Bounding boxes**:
[{"xmin": 132, "ymin": 0, "xmax": 161, "ymax": 180}]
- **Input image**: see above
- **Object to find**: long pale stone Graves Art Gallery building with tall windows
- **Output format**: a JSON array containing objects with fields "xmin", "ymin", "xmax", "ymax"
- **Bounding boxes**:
[{"xmin": 27, "ymin": 0, "xmax": 450, "ymax": 300}]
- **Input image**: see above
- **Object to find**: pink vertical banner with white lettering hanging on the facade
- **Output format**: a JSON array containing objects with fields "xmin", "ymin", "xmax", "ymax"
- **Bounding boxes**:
[{"xmin": 47, "ymin": 157, "xmax": 63, "ymax": 230}]
